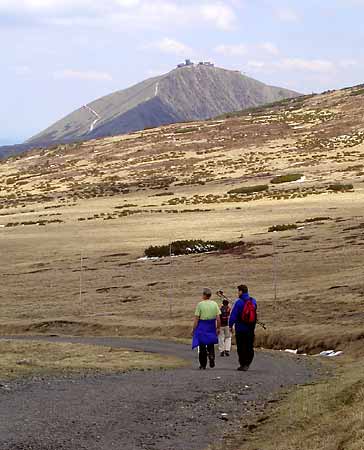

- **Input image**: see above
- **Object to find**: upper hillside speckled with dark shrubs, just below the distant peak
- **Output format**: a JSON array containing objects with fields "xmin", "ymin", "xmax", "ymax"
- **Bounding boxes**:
[{"xmin": 0, "ymin": 86, "xmax": 364, "ymax": 208}]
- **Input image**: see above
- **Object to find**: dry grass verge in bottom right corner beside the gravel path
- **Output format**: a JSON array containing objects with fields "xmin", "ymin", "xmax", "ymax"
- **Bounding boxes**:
[{"xmin": 210, "ymin": 360, "xmax": 364, "ymax": 450}]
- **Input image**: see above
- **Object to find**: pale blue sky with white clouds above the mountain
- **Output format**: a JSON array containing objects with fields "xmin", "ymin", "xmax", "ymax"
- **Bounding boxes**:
[{"xmin": 0, "ymin": 0, "xmax": 364, "ymax": 145}]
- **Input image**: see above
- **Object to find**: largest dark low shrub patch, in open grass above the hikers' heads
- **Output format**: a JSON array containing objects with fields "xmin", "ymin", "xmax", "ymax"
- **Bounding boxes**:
[{"xmin": 144, "ymin": 239, "xmax": 241, "ymax": 258}]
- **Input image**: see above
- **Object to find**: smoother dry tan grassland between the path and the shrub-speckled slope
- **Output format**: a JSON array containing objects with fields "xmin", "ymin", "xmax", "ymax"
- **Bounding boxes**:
[{"xmin": 0, "ymin": 193, "xmax": 364, "ymax": 352}]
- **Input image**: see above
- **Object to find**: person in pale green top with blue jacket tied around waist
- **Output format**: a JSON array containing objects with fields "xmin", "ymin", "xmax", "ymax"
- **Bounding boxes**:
[{"xmin": 192, "ymin": 288, "xmax": 221, "ymax": 370}]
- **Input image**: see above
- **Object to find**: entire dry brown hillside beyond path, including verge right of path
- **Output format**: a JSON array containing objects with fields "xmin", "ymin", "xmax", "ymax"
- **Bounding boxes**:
[{"xmin": 0, "ymin": 82, "xmax": 364, "ymax": 450}]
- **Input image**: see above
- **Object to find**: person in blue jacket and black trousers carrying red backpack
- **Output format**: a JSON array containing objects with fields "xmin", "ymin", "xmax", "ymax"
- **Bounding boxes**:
[{"xmin": 229, "ymin": 284, "xmax": 257, "ymax": 371}]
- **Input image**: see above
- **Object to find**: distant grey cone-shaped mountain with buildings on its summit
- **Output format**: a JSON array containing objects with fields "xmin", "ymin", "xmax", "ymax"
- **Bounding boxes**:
[{"xmin": 26, "ymin": 65, "xmax": 299, "ymax": 146}]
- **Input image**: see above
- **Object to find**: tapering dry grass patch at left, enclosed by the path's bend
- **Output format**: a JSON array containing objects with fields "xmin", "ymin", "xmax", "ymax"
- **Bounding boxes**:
[{"xmin": 0, "ymin": 341, "xmax": 184, "ymax": 380}]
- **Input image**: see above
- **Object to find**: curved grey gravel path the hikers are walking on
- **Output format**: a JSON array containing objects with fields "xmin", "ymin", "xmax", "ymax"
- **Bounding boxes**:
[{"xmin": 0, "ymin": 337, "xmax": 314, "ymax": 450}]
